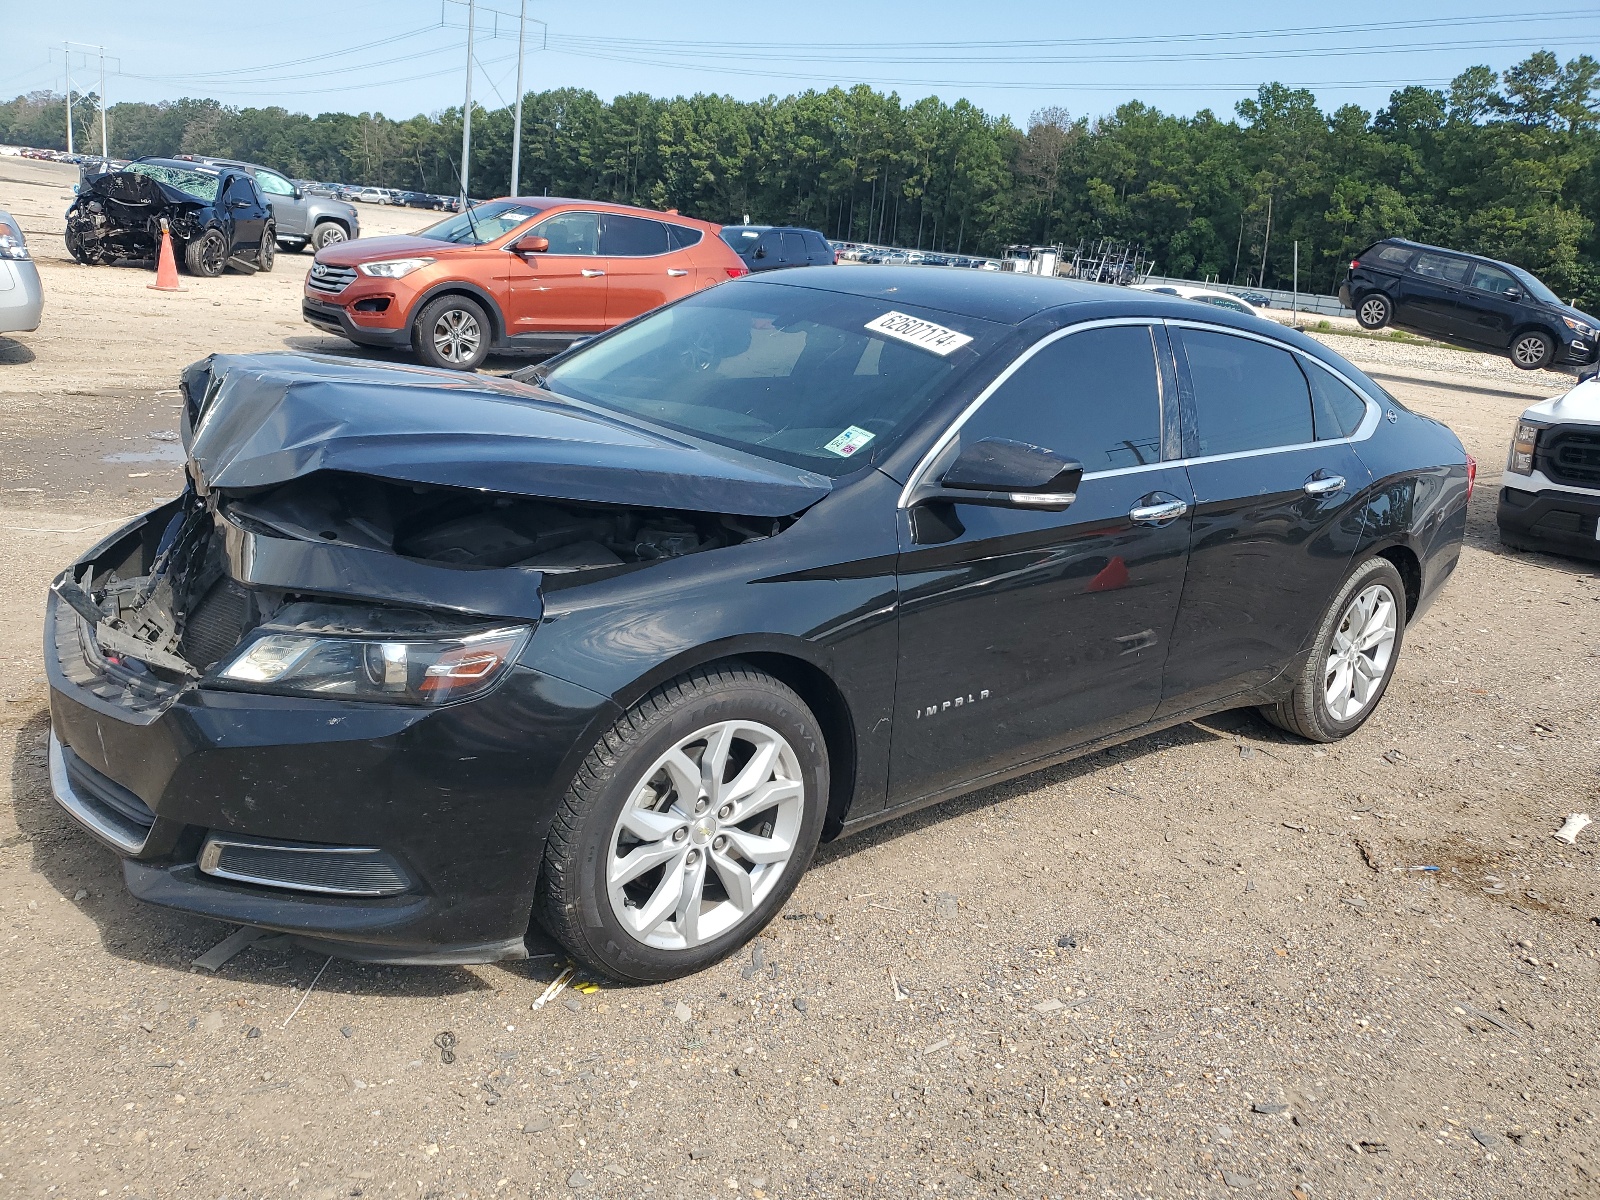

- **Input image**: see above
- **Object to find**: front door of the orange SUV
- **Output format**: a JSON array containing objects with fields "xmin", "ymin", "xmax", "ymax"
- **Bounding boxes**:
[{"xmin": 504, "ymin": 213, "xmax": 610, "ymax": 338}]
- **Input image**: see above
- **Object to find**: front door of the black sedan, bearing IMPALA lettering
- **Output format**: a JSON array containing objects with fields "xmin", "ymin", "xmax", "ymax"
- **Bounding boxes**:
[{"xmin": 890, "ymin": 323, "xmax": 1192, "ymax": 805}]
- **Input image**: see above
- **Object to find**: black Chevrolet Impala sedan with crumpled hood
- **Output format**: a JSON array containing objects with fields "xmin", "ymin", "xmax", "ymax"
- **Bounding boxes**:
[{"xmin": 45, "ymin": 267, "xmax": 1474, "ymax": 981}]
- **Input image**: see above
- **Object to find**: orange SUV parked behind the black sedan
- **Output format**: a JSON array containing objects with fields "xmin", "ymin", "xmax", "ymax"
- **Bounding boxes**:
[{"xmin": 301, "ymin": 197, "xmax": 747, "ymax": 371}]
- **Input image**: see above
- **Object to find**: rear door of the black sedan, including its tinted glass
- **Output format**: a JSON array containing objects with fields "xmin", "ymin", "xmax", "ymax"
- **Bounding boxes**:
[{"xmin": 1162, "ymin": 326, "xmax": 1371, "ymax": 714}]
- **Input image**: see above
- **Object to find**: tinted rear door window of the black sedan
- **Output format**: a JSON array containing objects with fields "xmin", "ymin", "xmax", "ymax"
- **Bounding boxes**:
[{"xmin": 1181, "ymin": 330, "xmax": 1315, "ymax": 458}]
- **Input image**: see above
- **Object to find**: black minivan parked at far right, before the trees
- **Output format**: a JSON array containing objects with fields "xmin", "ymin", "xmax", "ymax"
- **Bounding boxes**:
[{"xmin": 1339, "ymin": 237, "xmax": 1600, "ymax": 371}]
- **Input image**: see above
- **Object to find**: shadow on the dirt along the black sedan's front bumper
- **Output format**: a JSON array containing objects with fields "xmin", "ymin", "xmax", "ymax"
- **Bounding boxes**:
[{"xmin": 11, "ymin": 709, "xmax": 524, "ymax": 997}]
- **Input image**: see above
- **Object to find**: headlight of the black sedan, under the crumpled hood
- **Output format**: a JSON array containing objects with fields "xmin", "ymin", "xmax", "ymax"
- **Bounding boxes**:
[{"xmin": 208, "ymin": 604, "xmax": 531, "ymax": 706}]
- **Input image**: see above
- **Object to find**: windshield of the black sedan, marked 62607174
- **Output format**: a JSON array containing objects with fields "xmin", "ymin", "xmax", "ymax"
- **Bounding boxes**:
[{"xmin": 544, "ymin": 282, "xmax": 1008, "ymax": 475}]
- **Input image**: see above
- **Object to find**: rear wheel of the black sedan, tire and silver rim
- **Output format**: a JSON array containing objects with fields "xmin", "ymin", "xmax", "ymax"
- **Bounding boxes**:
[{"xmin": 1261, "ymin": 558, "xmax": 1406, "ymax": 742}]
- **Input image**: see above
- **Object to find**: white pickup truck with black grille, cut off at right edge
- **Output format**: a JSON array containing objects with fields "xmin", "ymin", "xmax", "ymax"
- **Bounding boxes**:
[{"xmin": 1494, "ymin": 374, "xmax": 1600, "ymax": 558}]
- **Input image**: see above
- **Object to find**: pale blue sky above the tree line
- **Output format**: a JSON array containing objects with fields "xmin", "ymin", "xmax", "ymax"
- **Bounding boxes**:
[{"xmin": 0, "ymin": 0, "xmax": 1600, "ymax": 123}]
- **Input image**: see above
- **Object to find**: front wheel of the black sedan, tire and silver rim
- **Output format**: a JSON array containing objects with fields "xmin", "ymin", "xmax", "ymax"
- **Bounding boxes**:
[{"xmin": 536, "ymin": 661, "xmax": 829, "ymax": 984}]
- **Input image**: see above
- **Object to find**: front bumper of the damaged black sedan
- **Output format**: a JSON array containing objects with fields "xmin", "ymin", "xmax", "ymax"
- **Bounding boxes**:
[{"xmin": 45, "ymin": 507, "xmax": 618, "ymax": 962}]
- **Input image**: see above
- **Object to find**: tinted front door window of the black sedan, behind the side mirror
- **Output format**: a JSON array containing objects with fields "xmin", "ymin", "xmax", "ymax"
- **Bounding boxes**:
[{"xmin": 962, "ymin": 325, "xmax": 1162, "ymax": 472}]
